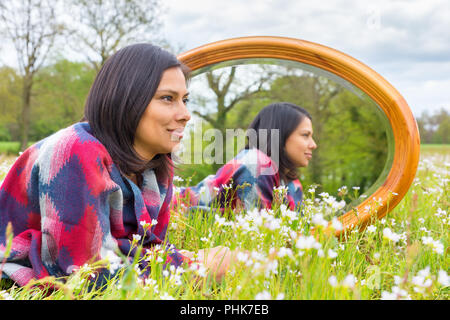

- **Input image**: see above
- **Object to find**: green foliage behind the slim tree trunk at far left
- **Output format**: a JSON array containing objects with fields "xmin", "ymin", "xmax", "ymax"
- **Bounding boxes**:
[{"xmin": 0, "ymin": 59, "xmax": 95, "ymax": 141}]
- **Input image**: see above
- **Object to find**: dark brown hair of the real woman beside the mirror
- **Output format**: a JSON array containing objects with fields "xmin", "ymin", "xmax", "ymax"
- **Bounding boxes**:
[{"xmin": 83, "ymin": 43, "xmax": 189, "ymax": 181}]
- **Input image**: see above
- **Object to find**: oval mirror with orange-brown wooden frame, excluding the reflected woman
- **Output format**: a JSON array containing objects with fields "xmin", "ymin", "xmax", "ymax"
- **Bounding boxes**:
[{"xmin": 178, "ymin": 37, "xmax": 420, "ymax": 235}]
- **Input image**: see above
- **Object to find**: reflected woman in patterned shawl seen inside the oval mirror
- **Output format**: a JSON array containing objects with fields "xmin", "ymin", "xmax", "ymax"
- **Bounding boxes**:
[{"xmin": 172, "ymin": 102, "xmax": 317, "ymax": 210}]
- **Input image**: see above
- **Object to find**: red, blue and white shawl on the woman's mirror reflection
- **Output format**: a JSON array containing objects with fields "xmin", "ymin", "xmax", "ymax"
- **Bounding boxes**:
[{"xmin": 171, "ymin": 149, "xmax": 303, "ymax": 214}]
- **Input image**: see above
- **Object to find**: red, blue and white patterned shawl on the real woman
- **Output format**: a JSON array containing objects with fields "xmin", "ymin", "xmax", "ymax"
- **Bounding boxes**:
[{"xmin": 0, "ymin": 123, "xmax": 186, "ymax": 286}]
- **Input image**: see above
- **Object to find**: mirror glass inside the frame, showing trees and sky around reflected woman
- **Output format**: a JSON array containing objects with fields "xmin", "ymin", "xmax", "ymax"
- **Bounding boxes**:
[{"xmin": 176, "ymin": 58, "xmax": 394, "ymax": 213}]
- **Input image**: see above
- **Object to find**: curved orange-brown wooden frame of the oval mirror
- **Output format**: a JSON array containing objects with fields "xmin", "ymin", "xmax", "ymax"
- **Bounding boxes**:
[{"xmin": 178, "ymin": 36, "xmax": 420, "ymax": 236}]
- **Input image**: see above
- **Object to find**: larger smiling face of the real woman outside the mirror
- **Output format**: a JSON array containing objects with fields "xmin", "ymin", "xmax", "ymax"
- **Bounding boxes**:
[{"xmin": 133, "ymin": 67, "xmax": 191, "ymax": 160}]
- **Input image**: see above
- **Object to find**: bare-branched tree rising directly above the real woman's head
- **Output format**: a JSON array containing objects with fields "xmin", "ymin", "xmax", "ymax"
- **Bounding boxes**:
[{"xmin": 66, "ymin": 0, "xmax": 161, "ymax": 71}]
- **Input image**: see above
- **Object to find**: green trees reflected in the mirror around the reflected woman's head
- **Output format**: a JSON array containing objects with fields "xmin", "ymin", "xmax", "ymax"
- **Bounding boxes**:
[{"xmin": 179, "ymin": 61, "xmax": 388, "ymax": 195}]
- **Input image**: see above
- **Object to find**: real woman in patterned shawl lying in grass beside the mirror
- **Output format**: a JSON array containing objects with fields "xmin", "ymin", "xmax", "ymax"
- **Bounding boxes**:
[{"xmin": 0, "ymin": 44, "xmax": 229, "ymax": 286}]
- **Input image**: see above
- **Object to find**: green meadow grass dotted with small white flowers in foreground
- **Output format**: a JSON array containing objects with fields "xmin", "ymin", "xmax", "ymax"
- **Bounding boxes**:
[{"xmin": 0, "ymin": 146, "xmax": 450, "ymax": 300}]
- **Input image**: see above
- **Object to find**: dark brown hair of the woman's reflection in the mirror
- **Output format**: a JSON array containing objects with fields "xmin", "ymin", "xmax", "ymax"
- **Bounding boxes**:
[{"xmin": 245, "ymin": 102, "xmax": 312, "ymax": 181}]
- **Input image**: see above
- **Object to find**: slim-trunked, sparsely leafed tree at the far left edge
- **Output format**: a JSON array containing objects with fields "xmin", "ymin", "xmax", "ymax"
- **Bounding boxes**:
[{"xmin": 0, "ymin": 0, "xmax": 63, "ymax": 150}]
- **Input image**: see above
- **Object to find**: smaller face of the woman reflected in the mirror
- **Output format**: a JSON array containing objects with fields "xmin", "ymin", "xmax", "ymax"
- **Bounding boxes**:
[{"xmin": 284, "ymin": 117, "xmax": 317, "ymax": 167}]
